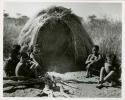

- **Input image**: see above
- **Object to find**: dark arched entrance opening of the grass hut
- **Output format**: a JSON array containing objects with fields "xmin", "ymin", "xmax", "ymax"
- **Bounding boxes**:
[{"xmin": 36, "ymin": 19, "xmax": 75, "ymax": 72}]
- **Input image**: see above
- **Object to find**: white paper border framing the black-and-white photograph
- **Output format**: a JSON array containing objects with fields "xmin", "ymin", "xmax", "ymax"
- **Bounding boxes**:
[{"xmin": 0, "ymin": 0, "xmax": 125, "ymax": 100}]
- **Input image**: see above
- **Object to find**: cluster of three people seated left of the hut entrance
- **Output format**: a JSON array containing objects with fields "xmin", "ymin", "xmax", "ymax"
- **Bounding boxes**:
[{"xmin": 4, "ymin": 45, "xmax": 40, "ymax": 78}]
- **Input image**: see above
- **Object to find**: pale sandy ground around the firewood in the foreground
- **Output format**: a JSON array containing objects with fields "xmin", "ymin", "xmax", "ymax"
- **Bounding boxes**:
[{"xmin": 3, "ymin": 71, "xmax": 121, "ymax": 98}]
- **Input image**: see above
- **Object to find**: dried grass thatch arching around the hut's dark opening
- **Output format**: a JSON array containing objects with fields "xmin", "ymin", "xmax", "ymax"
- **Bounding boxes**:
[{"xmin": 19, "ymin": 6, "xmax": 93, "ymax": 69}]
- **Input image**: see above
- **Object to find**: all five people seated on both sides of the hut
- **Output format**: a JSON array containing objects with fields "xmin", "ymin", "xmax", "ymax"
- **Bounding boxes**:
[{"xmin": 4, "ymin": 45, "xmax": 121, "ymax": 88}]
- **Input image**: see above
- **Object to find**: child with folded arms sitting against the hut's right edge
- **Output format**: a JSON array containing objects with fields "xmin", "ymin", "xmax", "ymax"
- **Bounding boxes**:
[{"xmin": 85, "ymin": 45, "xmax": 101, "ymax": 78}]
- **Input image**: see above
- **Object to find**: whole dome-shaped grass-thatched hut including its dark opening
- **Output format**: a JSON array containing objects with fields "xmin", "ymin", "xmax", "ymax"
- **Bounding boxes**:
[{"xmin": 19, "ymin": 7, "xmax": 93, "ymax": 72}]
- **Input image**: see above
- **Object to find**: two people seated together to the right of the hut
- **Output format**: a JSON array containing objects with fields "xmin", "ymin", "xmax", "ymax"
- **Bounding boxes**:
[{"xmin": 85, "ymin": 45, "xmax": 120, "ymax": 88}]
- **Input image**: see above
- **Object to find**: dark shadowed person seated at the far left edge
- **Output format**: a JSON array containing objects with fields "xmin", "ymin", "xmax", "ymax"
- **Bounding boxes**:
[{"xmin": 4, "ymin": 45, "xmax": 21, "ymax": 76}]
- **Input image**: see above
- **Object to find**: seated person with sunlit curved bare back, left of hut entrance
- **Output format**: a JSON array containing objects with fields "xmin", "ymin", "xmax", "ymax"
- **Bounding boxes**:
[{"xmin": 15, "ymin": 53, "xmax": 39, "ymax": 78}]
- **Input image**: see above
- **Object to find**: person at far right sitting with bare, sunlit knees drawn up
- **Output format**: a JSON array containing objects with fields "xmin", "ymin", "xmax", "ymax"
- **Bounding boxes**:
[{"xmin": 96, "ymin": 54, "xmax": 118, "ymax": 89}]
